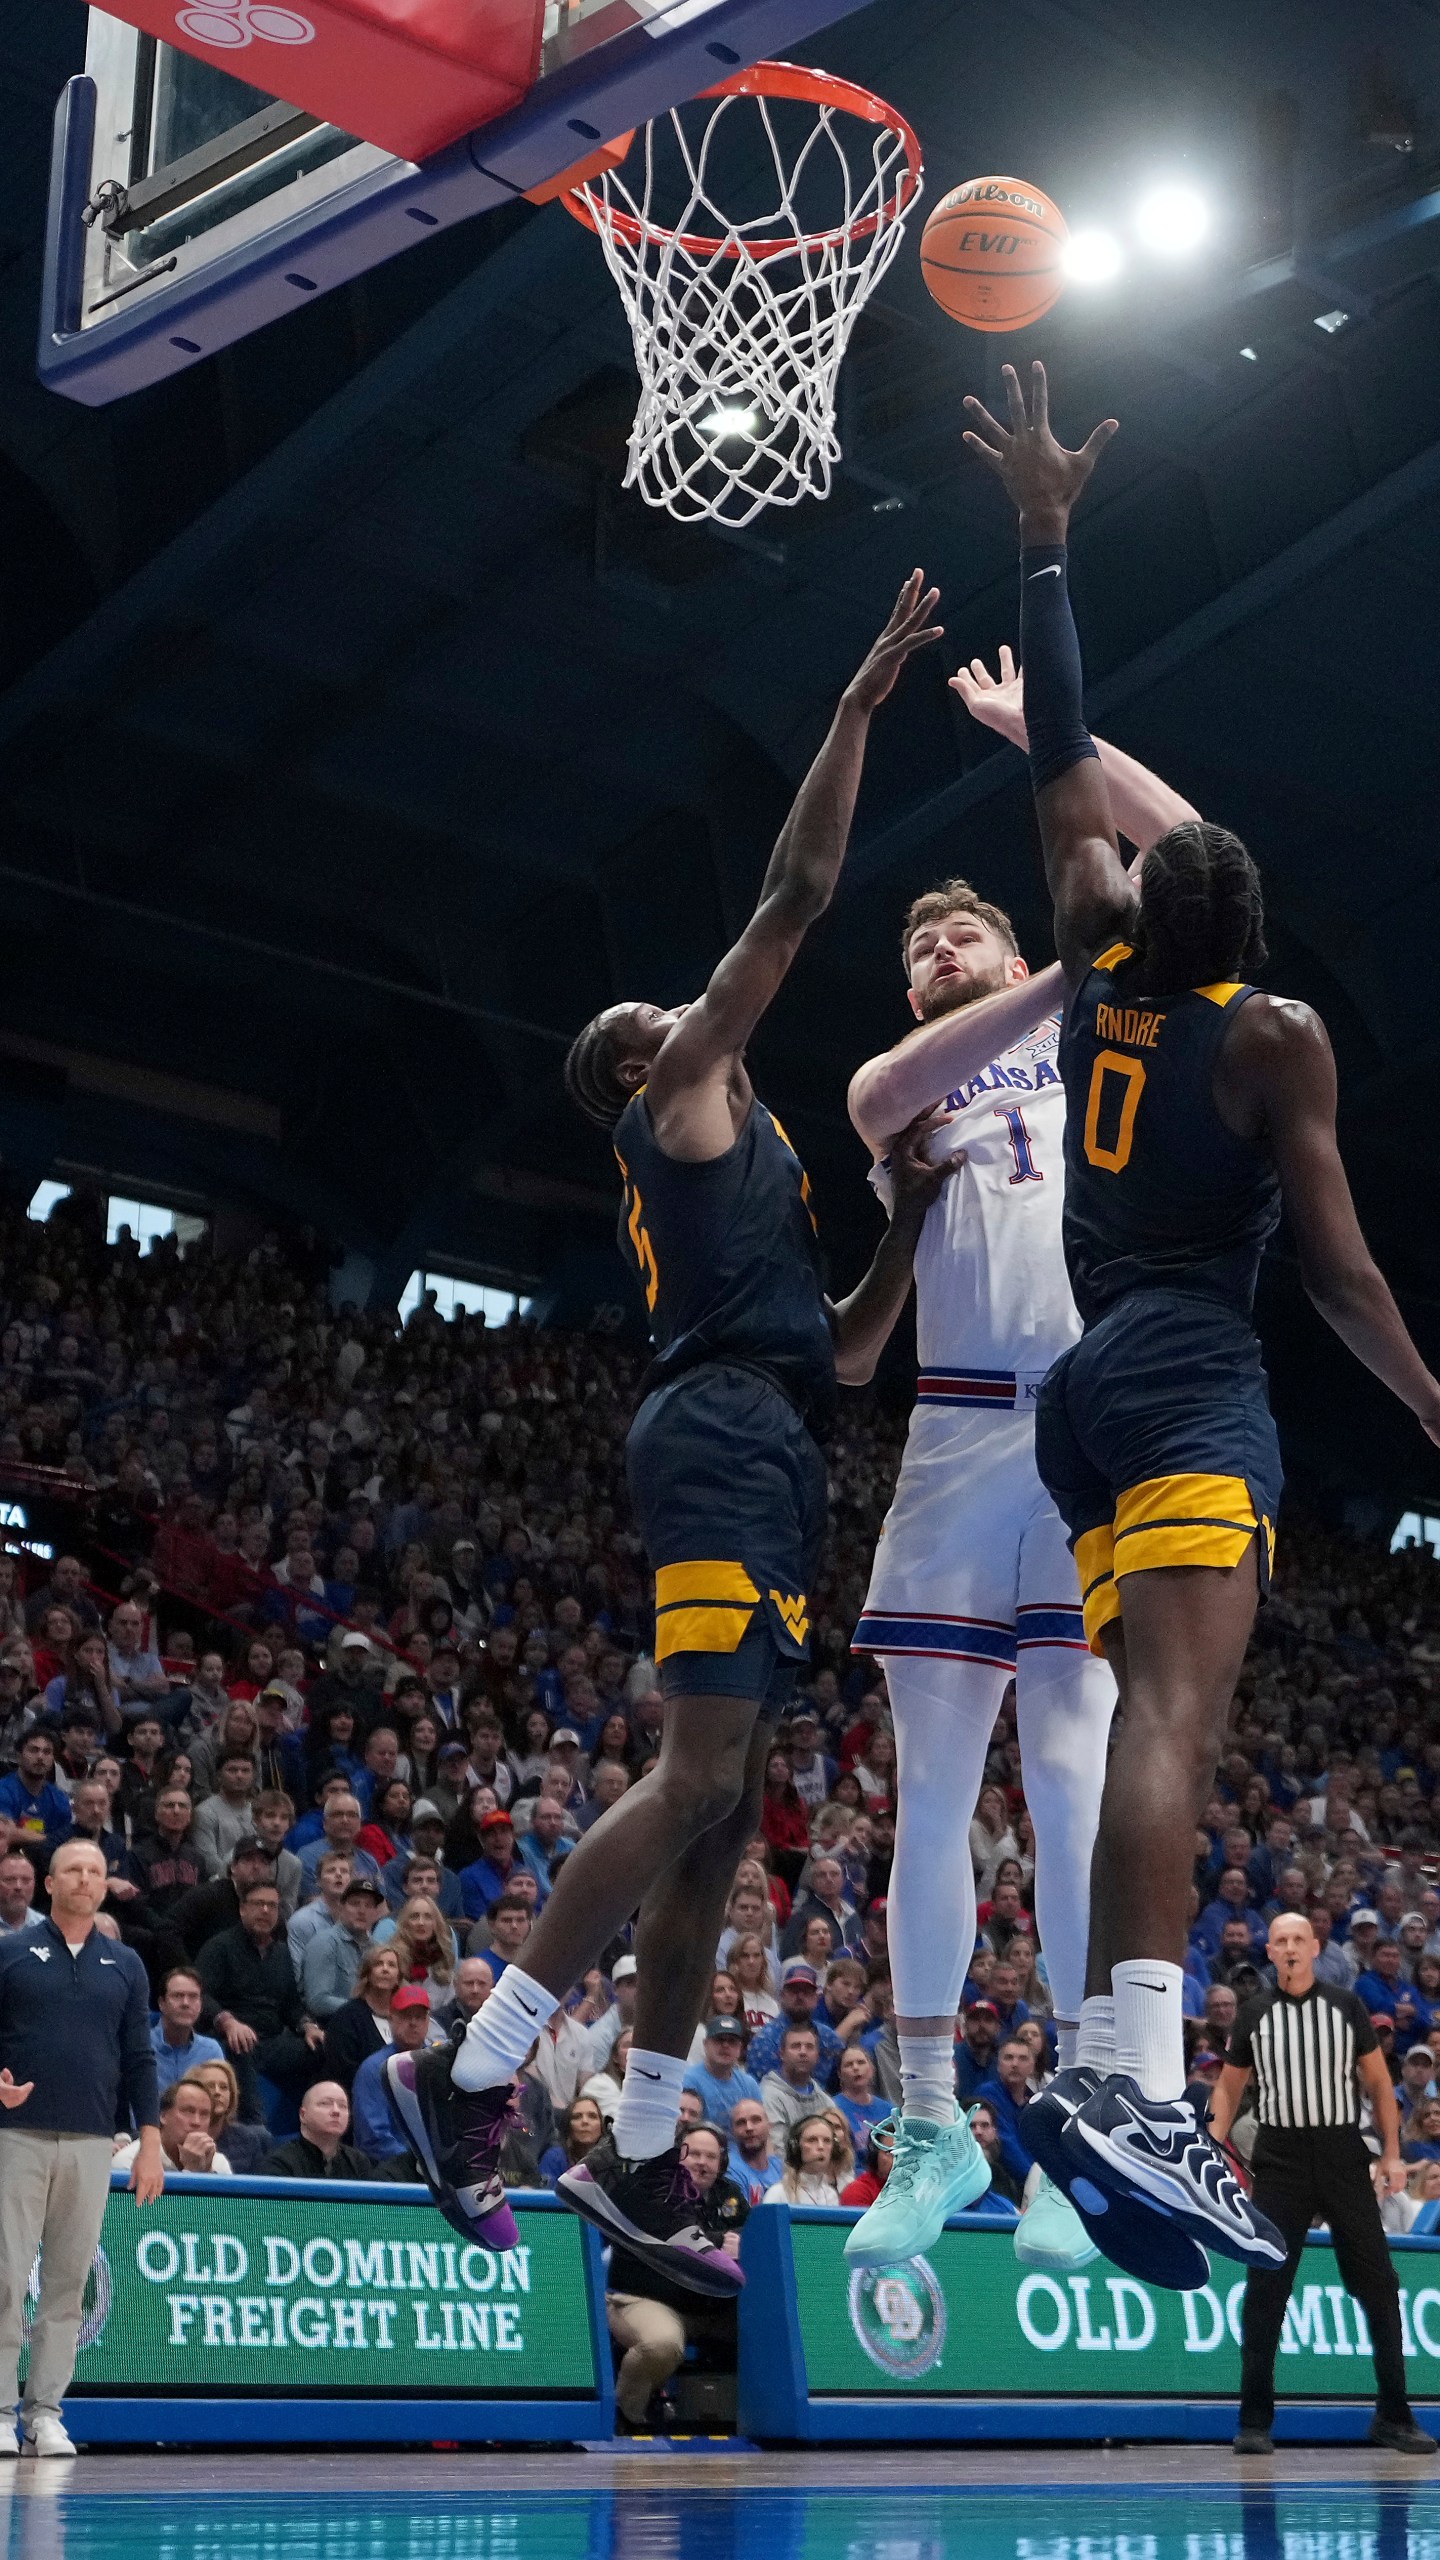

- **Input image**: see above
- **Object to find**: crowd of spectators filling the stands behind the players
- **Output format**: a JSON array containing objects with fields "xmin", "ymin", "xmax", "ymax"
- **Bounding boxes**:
[{"xmin": 0, "ymin": 1203, "xmax": 1440, "ymax": 2385}]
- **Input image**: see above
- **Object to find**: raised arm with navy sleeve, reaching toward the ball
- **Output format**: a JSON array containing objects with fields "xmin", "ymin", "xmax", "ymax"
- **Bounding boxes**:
[{"xmin": 966, "ymin": 364, "xmax": 1138, "ymax": 983}]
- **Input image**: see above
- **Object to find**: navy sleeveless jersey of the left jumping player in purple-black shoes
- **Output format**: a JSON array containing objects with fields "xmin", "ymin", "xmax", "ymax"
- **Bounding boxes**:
[{"xmin": 615, "ymin": 1093, "xmax": 835, "ymax": 1431}]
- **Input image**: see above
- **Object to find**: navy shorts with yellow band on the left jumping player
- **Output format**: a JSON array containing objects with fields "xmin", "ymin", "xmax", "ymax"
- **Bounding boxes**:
[{"xmin": 625, "ymin": 1359, "xmax": 828, "ymax": 1715}]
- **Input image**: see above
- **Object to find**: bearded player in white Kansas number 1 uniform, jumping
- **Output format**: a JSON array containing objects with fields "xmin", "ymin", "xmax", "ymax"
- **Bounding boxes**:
[{"xmin": 846, "ymin": 670, "xmax": 1194, "ymax": 2268}]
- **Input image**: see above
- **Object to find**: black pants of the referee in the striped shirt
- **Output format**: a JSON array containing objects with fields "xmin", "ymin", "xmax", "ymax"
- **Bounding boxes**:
[{"xmin": 1240, "ymin": 2127, "xmax": 1409, "ymax": 2429}]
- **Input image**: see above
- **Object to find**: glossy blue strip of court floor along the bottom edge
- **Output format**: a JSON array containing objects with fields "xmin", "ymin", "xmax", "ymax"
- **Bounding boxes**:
[{"xmin": 0, "ymin": 2488, "xmax": 1440, "ymax": 2560}]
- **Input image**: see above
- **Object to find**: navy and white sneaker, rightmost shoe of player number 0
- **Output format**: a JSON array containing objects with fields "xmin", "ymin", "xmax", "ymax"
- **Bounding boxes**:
[{"xmin": 1060, "ymin": 2074, "xmax": 1286, "ymax": 2266}]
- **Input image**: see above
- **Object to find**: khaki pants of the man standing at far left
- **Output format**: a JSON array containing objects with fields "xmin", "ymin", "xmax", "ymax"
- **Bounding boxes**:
[{"xmin": 0, "ymin": 2125, "xmax": 113, "ymax": 2427}]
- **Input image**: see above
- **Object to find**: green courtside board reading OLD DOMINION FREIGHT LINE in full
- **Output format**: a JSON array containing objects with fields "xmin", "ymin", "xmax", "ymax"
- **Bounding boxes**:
[{"xmin": 26, "ymin": 2179, "xmax": 599, "ymax": 2409}]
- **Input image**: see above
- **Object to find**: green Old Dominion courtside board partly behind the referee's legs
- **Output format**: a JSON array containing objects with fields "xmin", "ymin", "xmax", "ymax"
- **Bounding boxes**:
[{"xmin": 746, "ymin": 2212, "xmax": 1440, "ymax": 2432}]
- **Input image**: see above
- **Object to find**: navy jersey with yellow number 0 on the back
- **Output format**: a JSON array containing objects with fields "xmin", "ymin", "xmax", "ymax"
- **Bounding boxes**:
[{"xmin": 1061, "ymin": 942, "xmax": 1281, "ymax": 1324}]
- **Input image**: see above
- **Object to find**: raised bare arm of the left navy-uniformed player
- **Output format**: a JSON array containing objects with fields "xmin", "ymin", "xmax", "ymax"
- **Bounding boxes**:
[{"xmin": 648, "ymin": 568, "xmax": 943, "ymax": 1144}]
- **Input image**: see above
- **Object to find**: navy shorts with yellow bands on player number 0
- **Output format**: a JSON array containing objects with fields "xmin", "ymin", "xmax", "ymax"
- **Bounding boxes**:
[{"xmin": 1035, "ymin": 1290, "xmax": 1284, "ymax": 1654}]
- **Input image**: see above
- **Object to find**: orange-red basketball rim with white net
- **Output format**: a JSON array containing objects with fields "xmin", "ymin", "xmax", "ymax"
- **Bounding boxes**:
[{"xmin": 564, "ymin": 61, "xmax": 925, "ymax": 527}]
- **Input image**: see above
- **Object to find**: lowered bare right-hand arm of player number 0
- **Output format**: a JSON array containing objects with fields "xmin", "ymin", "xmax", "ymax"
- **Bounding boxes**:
[{"xmin": 1217, "ymin": 996, "xmax": 1440, "ymax": 1441}]
